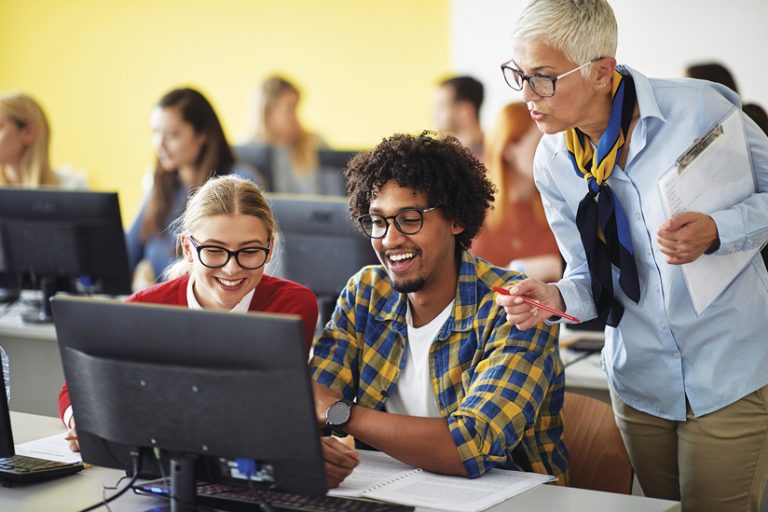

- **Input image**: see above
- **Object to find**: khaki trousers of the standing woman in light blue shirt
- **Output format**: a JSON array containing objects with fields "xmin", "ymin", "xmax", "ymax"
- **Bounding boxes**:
[{"xmin": 611, "ymin": 386, "xmax": 768, "ymax": 512}]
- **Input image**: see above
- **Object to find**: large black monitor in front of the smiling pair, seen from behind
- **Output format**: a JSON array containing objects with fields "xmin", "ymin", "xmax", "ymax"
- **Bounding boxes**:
[{"xmin": 52, "ymin": 295, "xmax": 327, "ymax": 504}]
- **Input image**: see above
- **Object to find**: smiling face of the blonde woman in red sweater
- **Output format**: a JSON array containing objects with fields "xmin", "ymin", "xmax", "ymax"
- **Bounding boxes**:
[{"xmin": 182, "ymin": 214, "xmax": 272, "ymax": 310}]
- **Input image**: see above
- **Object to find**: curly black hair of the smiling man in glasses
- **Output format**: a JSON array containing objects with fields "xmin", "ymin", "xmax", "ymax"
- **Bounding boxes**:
[{"xmin": 344, "ymin": 131, "xmax": 496, "ymax": 249}]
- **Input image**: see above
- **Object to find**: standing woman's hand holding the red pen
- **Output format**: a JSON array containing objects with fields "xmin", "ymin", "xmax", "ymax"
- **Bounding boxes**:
[{"xmin": 496, "ymin": 278, "xmax": 565, "ymax": 331}]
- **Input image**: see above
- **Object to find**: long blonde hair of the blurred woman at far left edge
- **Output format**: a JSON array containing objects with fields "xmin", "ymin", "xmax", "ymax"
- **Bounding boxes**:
[{"xmin": 0, "ymin": 93, "xmax": 59, "ymax": 188}]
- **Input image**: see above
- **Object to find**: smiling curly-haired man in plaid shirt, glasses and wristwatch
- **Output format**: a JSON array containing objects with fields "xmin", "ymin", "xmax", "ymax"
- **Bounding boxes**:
[{"xmin": 310, "ymin": 132, "xmax": 567, "ymax": 487}]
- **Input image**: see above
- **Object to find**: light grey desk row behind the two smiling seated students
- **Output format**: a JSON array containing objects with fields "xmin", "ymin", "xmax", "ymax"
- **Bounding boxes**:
[{"xmin": 0, "ymin": 307, "xmax": 610, "ymax": 416}]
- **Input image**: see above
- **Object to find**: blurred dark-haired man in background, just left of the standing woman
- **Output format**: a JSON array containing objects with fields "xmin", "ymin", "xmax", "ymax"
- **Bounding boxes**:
[{"xmin": 434, "ymin": 75, "xmax": 485, "ymax": 162}]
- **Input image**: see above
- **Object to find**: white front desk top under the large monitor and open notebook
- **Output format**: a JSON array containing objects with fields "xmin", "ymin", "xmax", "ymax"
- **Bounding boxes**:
[{"xmin": 0, "ymin": 412, "xmax": 680, "ymax": 512}]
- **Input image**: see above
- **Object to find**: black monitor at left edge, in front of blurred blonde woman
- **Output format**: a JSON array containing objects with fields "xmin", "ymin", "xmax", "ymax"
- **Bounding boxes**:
[{"xmin": 0, "ymin": 188, "xmax": 131, "ymax": 322}]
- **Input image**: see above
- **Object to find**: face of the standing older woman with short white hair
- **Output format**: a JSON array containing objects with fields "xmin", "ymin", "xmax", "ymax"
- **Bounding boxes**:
[{"xmin": 513, "ymin": 41, "xmax": 616, "ymax": 138}]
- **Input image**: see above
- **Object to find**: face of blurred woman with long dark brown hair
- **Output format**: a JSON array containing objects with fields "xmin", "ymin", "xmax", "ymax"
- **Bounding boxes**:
[{"xmin": 150, "ymin": 107, "xmax": 205, "ymax": 171}]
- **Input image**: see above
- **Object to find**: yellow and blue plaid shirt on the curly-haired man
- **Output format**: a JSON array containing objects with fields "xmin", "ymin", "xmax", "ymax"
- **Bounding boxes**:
[{"xmin": 310, "ymin": 251, "xmax": 568, "ymax": 484}]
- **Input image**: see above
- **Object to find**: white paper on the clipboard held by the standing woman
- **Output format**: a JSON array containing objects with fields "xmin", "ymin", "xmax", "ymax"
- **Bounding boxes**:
[{"xmin": 659, "ymin": 109, "xmax": 759, "ymax": 315}]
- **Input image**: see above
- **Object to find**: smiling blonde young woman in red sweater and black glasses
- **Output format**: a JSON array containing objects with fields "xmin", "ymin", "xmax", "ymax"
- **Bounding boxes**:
[{"xmin": 59, "ymin": 176, "xmax": 317, "ymax": 450}]
